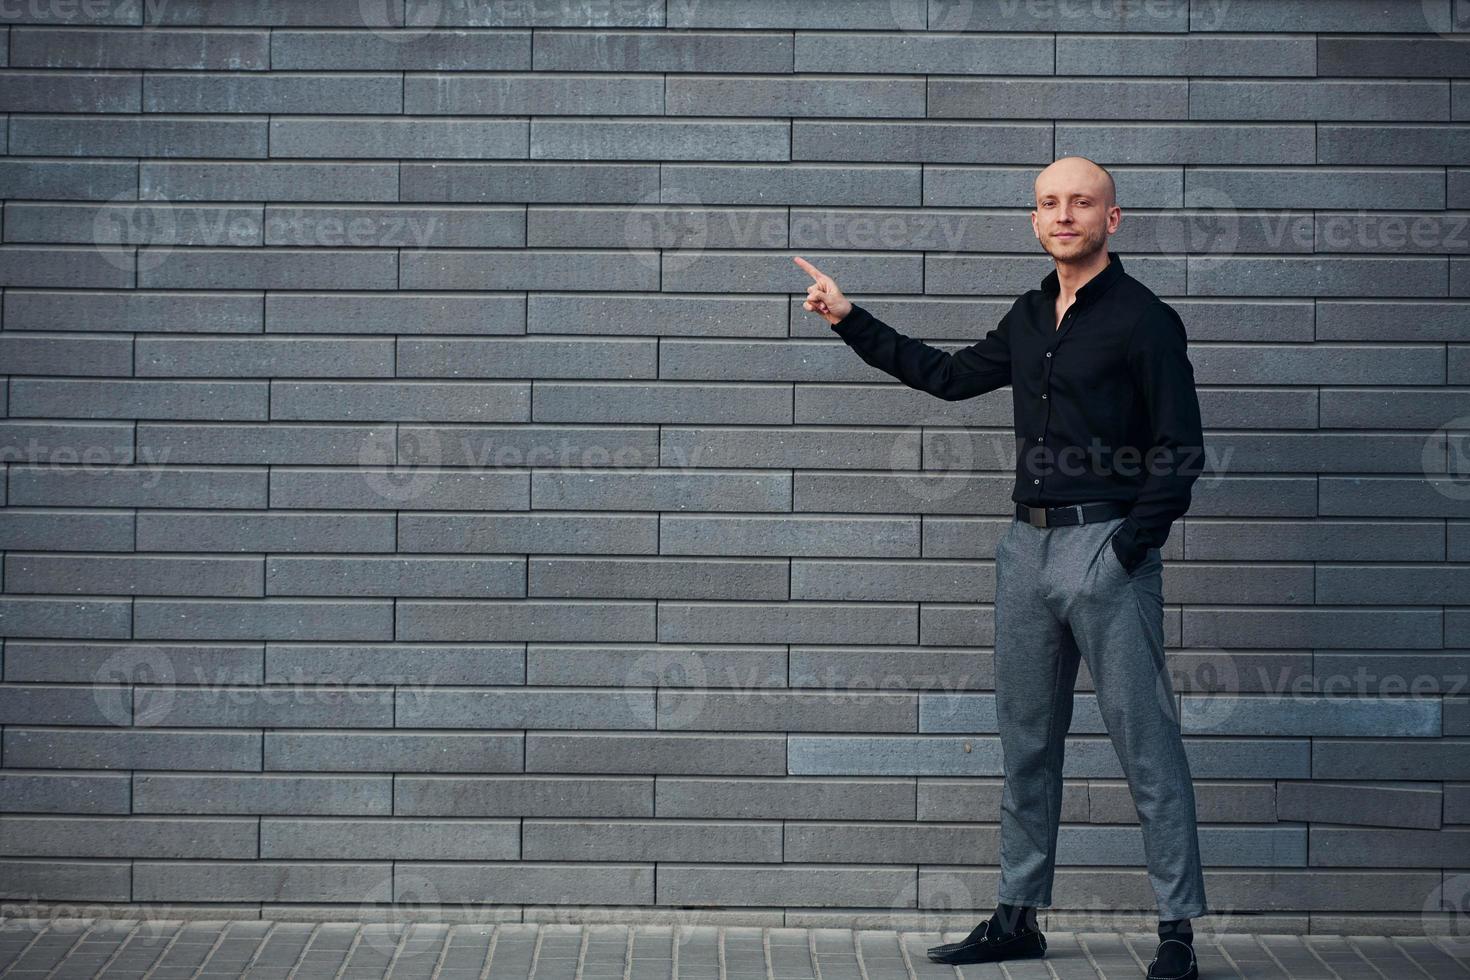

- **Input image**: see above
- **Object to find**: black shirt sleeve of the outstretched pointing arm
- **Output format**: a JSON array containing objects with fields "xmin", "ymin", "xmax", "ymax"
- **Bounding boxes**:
[{"xmin": 832, "ymin": 303, "xmax": 1011, "ymax": 401}]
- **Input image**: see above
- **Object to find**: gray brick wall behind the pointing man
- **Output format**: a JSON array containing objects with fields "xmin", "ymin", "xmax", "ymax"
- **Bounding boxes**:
[{"xmin": 0, "ymin": 0, "xmax": 1470, "ymax": 932}]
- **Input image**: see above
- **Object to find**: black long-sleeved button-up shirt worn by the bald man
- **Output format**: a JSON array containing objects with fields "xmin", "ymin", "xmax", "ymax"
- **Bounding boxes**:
[{"xmin": 832, "ymin": 253, "xmax": 1204, "ymax": 572}]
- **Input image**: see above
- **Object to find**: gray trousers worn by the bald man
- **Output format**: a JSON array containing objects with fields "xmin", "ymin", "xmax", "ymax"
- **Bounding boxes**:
[{"xmin": 995, "ymin": 517, "xmax": 1207, "ymax": 918}]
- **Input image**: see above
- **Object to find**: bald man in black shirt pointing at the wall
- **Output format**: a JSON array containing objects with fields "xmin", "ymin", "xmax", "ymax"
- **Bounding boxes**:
[{"xmin": 795, "ymin": 157, "xmax": 1207, "ymax": 980}]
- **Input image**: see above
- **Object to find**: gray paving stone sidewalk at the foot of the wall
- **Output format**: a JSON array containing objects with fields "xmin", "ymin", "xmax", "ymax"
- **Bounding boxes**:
[{"xmin": 0, "ymin": 918, "xmax": 1470, "ymax": 980}]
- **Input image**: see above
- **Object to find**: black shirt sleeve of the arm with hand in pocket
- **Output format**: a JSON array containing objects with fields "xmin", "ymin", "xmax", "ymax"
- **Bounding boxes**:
[{"xmin": 1111, "ymin": 303, "xmax": 1204, "ymax": 572}]
